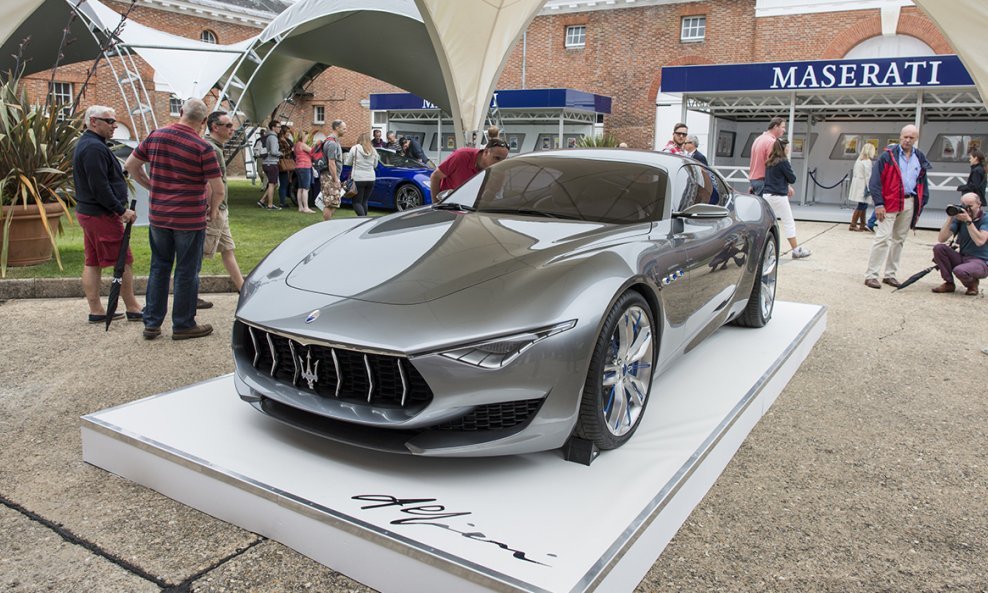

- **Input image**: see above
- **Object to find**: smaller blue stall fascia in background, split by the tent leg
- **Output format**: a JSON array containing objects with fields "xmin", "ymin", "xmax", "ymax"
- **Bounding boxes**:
[{"xmin": 370, "ymin": 89, "xmax": 611, "ymax": 113}]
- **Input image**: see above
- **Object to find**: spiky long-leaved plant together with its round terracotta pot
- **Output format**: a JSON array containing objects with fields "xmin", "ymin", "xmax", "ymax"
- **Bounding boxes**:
[{"xmin": 0, "ymin": 72, "xmax": 82, "ymax": 277}]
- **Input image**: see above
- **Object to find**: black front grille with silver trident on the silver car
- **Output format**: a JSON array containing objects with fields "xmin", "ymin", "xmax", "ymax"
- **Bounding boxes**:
[{"xmin": 240, "ymin": 326, "xmax": 432, "ymax": 408}]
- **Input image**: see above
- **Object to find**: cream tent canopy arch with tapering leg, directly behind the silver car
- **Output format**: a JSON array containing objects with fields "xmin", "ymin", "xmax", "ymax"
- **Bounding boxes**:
[{"xmin": 223, "ymin": 0, "xmax": 544, "ymax": 143}]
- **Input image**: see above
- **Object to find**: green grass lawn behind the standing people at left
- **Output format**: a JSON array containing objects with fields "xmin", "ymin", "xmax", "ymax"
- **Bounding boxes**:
[{"xmin": 7, "ymin": 180, "xmax": 366, "ymax": 278}]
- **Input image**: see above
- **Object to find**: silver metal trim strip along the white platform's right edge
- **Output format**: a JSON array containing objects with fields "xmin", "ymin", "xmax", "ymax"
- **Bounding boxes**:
[{"xmin": 570, "ymin": 305, "xmax": 827, "ymax": 593}]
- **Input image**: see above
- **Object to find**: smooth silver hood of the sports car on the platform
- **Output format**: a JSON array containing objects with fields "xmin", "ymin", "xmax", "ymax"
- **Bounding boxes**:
[{"xmin": 286, "ymin": 208, "xmax": 650, "ymax": 305}]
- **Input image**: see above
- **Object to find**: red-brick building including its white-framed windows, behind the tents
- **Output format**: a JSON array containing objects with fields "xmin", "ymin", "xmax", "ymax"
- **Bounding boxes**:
[{"xmin": 29, "ymin": 0, "xmax": 954, "ymax": 153}]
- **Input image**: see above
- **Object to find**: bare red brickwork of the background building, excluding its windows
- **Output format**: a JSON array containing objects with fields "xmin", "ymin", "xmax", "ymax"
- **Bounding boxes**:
[{"xmin": 19, "ymin": 0, "xmax": 953, "ymax": 156}]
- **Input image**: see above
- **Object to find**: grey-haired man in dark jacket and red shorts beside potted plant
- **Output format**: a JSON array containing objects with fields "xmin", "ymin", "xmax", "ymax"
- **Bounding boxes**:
[{"xmin": 72, "ymin": 105, "xmax": 143, "ymax": 323}]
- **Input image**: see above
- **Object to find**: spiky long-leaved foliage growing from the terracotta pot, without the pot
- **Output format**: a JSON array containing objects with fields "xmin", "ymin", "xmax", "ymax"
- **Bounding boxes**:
[{"xmin": 0, "ymin": 73, "xmax": 82, "ymax": 277}]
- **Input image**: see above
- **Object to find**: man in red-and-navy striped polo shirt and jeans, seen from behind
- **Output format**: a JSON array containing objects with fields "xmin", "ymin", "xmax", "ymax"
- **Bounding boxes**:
[{"xmin": 124, "ymin": 99, "xmax": 223, "ymax": 340}]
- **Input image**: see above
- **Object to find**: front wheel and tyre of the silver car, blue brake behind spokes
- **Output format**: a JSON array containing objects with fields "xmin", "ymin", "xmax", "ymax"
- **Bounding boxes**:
[{"xmin": 576, "ymin": 291, "xmax": 657, "ymax": 450}]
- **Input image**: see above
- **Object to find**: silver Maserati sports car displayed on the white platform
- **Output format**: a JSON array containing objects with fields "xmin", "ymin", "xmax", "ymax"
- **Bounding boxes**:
[{"xmin": 233, "ymin": 149, "xmax": 779, "ymax": 456}]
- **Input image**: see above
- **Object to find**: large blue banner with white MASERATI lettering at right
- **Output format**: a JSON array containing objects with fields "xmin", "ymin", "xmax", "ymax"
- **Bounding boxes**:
[{"xmin": 662, "ymin": 55, "xmax": 974, "ymax": 93}]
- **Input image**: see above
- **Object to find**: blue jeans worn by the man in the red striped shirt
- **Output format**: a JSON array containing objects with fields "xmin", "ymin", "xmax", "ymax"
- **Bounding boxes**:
[{"xmin": 144, "ymin": 226, "xmax": 206, "ymax": 329}]
